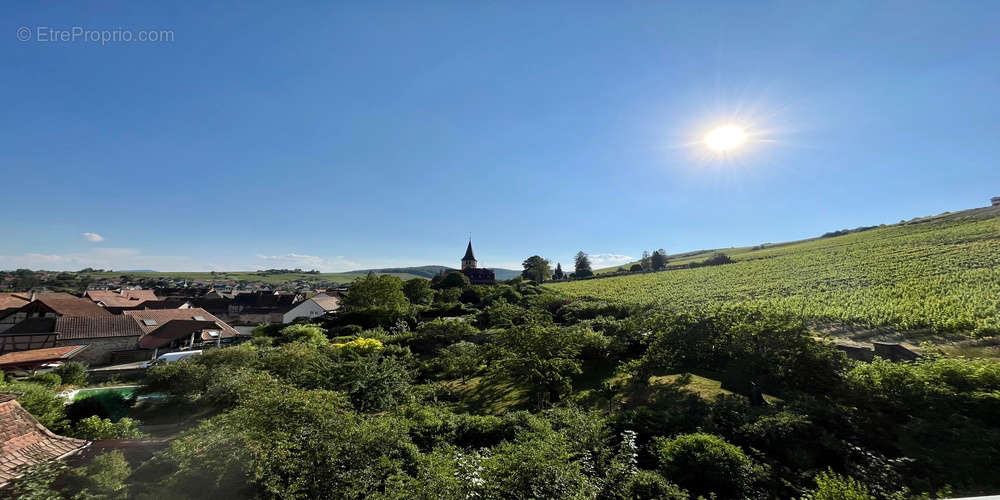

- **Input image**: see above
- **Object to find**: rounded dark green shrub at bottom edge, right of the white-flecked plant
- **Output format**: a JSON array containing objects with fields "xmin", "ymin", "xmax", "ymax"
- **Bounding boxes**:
[{"xmin": 655, "ymin": 433, "xmax": 758, "ymax": 498}]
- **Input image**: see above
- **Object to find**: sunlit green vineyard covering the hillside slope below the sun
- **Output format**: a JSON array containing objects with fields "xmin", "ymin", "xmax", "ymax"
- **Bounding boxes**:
[{"xmin": 550, "ymin": 214, "xmax": 1000, "ymax": 337}]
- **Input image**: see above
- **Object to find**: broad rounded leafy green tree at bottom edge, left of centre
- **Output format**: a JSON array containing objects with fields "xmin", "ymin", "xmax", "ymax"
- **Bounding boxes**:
[{"xmin": 158, "ymin": 390, "xmax": 419, "ymax": 499}]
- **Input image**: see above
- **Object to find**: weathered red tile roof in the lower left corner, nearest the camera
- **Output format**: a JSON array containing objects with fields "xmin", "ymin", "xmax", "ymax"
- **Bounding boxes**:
[{"xmin": 0, "ymin": 393, "xmax": 90, "ymax": 487}]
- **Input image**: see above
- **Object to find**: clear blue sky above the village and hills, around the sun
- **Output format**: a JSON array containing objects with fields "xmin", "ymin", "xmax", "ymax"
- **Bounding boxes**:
[{"xmin": 0, "ymin": 1, "xmax": 1000, "ymax": 271}]
